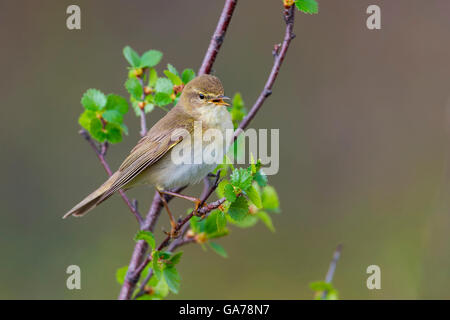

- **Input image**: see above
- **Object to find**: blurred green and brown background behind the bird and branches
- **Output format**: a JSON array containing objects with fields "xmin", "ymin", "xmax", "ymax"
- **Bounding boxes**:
[{"xmin": 0, "ymin": 0, "xmax": 450, "ymax": 299}]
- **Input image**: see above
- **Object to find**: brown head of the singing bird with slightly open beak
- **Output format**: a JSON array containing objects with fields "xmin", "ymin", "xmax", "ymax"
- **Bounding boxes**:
[{"xmin": 180, "ymin": 74, "xmax": 229, "ymax": 109}]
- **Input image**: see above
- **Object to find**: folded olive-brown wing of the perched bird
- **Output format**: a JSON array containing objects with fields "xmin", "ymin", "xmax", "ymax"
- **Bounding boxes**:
[{"xmin": 99, "ymin": 106, "xmax": 194, "ymax": 203}]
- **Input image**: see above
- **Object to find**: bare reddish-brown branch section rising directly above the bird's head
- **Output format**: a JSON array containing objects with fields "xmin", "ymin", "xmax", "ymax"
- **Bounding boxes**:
[{"xmin": 198, "ymin": 0, "xmax": 237, "ymax": 75}]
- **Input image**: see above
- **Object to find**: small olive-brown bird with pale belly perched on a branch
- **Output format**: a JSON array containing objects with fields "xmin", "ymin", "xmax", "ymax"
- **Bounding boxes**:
[{"xmin": 64, "ymin": 75, "xmax": 233, "ymax": 236}]
